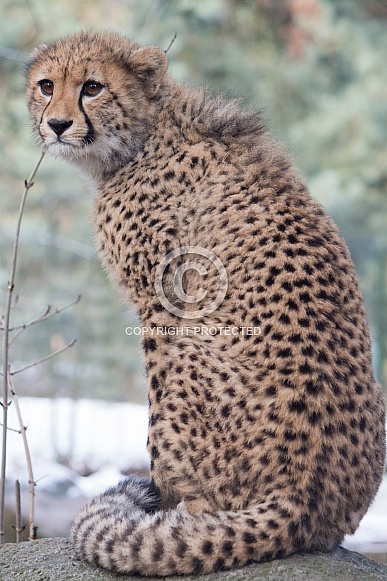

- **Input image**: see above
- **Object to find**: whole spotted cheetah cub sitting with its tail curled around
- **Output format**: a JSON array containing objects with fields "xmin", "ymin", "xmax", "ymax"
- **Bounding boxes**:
[{"xmin": 28, "ymin": 33, "xmax": 385, "ymax": 576}]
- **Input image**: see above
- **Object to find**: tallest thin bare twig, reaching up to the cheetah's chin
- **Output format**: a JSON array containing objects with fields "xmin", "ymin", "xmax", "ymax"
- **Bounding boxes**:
[{"xmin": 0, "ymin": 151, "xmax": 45, "ymax": 544}]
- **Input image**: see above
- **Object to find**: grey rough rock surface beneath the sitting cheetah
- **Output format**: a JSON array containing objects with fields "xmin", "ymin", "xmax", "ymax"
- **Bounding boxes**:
[{"xmin": 0, "ymin": 538, "xmax": 387, "ymax": 581}]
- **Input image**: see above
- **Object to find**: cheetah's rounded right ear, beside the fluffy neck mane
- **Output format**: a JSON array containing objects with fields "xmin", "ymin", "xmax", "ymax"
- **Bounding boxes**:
[{"xmin": 129, "ymin": 46, "xmax": 168, "ymax": 97}]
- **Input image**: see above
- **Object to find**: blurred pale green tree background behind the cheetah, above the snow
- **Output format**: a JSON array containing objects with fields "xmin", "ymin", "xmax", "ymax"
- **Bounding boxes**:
[{"xmin": 0, "ymin": 0, "xmax": 387, "ymax": 402}]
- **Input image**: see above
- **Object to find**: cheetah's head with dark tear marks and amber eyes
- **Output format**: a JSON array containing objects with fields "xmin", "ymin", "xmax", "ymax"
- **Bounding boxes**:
[{"xmin": 27, "ymin": 33, "xmax": 167, "ymax": 177}]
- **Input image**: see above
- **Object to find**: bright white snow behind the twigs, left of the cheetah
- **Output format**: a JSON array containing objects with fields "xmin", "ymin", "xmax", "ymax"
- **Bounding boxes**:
[{"xmin": 7, "ymin": 397, "xmax": 149, "ymax": 480}]
